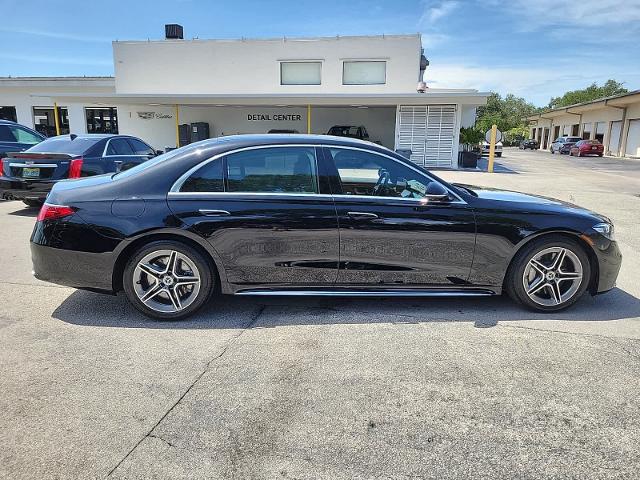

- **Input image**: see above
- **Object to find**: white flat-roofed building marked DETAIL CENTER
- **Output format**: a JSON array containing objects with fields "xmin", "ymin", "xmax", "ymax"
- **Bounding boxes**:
[{"xmin": 0, "ymin": 27, "xmax": 487, "ymax": 168}]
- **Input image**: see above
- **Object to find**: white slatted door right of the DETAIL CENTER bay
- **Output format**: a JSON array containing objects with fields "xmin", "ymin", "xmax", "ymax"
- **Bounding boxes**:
[{"xmin": 396, "ymin": 105, "xmax": 456, "ymax": 167}]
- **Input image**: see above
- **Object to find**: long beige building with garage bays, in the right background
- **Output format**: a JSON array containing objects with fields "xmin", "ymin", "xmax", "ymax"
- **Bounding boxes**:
[{"xmin": 528, "ymin": 90, "xmax": 640, "ymax": 157}]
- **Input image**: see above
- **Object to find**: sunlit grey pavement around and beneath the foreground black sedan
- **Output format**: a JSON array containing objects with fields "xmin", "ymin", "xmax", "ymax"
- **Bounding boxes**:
[{"xmin": 0, "ymin": 149, "xmax": 640, "ymax": 479}]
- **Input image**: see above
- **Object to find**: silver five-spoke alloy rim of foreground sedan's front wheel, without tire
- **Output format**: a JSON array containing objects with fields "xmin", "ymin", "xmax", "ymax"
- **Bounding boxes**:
[{"xmin": 522, "ymin": 247, "xmax": 584, "ymax": 307}]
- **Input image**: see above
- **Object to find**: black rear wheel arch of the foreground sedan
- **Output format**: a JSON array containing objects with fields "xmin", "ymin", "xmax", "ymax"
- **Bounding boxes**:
[{"xmin": 111, "ymin": 229, "xmax": 227, "ymax": 292}]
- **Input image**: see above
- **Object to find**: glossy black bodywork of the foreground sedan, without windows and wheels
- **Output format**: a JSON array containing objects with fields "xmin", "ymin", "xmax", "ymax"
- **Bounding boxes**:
[{"xmin": 32, "ymin": 135, "xmax": 621, "ymax": 294}]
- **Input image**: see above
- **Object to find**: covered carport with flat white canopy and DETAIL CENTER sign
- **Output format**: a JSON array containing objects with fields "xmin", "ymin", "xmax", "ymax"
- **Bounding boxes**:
[{"xmin": 32, "ymin": 90, "xmax": 486, "ymax": 168}]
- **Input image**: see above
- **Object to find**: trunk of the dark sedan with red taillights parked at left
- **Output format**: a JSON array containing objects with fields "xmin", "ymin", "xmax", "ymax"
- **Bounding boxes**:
[{"xmin": 3, "ymin": 152, "xmax": 82, "ymax": 181}]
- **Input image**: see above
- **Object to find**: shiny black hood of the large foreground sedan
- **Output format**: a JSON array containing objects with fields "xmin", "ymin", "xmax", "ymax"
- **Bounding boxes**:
[{"xmin": 455, "ymin": 184, "xmax": 610, "ymax": 222}]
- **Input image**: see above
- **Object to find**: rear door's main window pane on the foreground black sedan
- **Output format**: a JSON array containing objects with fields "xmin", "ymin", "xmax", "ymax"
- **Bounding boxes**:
[{"xmin": 226, "ymin": 146, "xmax": 318, "ymax": 194}]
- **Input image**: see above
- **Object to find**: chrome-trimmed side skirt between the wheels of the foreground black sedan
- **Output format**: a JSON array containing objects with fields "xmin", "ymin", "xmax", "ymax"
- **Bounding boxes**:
[{"xmin": 235, "ymin": 288, "xmax": 497, "ymax": 297}]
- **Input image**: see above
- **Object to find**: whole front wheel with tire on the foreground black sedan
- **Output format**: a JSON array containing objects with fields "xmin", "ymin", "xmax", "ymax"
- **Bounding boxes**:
[{"xmin": 505, "ymin": 235, "xmax": 591, "ymax": 312}]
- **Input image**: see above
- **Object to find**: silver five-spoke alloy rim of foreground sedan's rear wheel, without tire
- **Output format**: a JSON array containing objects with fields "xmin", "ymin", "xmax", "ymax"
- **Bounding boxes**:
[{"xmin": 132, "ymin": 250, "xmax": 201, "ymax": 313}]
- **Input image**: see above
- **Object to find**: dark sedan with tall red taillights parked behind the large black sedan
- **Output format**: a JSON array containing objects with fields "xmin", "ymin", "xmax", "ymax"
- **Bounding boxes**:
[{"xmin": 0, "ymin": 134, "xmax": 156, "ymax": 206}]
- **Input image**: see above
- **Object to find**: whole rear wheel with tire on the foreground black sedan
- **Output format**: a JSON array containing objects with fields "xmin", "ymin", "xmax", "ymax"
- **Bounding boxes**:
[{"xmin": 122, "ymin": 240, "xmax": 216, "ymax": 320}]
